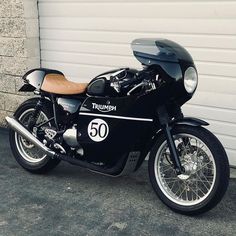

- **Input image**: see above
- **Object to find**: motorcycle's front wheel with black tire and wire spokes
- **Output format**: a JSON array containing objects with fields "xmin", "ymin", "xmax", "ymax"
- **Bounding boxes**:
[{"xmin": 148, "ymin": 125, "xmax": 229, "ymax": 215}]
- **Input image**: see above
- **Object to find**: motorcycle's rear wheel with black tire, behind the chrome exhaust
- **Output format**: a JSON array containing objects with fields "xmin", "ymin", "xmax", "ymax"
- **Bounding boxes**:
[{"xmin": 9, "ymin": 98, "xmax": 60, "ymax": 174}]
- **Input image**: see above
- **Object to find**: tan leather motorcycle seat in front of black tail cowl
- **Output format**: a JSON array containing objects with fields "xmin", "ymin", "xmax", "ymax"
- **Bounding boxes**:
[{"xmin": 41, "ymin": 74, "xmax": 88, "ymax": 95}]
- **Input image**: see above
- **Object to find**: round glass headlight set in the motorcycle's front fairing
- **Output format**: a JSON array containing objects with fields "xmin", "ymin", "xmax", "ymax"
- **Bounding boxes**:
[{"xmin": 184, "ymin": 67, "xmax": 198, "ymax": 93}]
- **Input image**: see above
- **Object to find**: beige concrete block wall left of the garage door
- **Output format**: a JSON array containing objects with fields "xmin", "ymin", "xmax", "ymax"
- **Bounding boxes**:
[{"xmin": 0, "ymin": 0, "xmax": 40, "ymax": 126}]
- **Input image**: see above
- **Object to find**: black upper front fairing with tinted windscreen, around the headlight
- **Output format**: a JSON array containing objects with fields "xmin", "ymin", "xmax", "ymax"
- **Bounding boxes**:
[{"xmin": 131, "ymin": 39, "xmax": 196, "ymax": 106}]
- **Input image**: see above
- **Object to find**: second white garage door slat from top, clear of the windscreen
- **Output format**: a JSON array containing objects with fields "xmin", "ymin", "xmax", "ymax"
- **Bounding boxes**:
[{"xmin": 40, "ymin": 16, "xmax": 236, "ymax": 35}]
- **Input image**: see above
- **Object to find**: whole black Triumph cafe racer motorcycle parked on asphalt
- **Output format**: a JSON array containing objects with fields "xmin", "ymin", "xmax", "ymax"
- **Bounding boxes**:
[{"xmin": 6, "ymin": 39, "xmax": 229, "ymax": 215}]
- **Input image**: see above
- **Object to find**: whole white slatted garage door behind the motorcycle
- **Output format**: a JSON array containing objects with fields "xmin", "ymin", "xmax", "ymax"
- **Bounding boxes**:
[{"xmin": 39, "ymin": 0, "xmax": 236, "ymax": 165}]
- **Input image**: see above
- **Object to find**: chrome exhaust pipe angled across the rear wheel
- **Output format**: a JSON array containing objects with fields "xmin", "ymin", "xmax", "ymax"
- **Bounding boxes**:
[{"xmin": 5, "ymin": 116, "xmax": 56, "ymax": 157}]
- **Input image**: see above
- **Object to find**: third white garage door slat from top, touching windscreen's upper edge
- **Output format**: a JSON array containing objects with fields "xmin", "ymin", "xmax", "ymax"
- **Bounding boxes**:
[{"xmin": 40, "ymin": 28, "xmax": 236, "ymax": 49}]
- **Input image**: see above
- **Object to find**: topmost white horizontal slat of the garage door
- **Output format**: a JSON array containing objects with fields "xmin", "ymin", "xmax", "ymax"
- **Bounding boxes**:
[{"xmin": 40, "ymin": 0, "xmax": 235, "ymax": 19}]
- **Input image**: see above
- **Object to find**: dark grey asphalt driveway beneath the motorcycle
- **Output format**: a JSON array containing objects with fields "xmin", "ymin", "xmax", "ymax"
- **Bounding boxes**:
[{"xmin": 0, "ymin": 129, "xmax": 236, "ymax": 236}]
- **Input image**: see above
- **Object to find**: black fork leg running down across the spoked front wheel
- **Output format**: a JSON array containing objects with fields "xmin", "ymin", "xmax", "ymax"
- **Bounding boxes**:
[{"xmin": 163, "ymin": 124, "xmax": 184, "ymax": 175}]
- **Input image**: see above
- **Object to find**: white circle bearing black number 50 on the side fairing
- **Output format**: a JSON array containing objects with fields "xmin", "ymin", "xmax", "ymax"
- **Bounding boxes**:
[{"xmin": 88, "ymin": 119, "xmax": 109, "ymax": 142}]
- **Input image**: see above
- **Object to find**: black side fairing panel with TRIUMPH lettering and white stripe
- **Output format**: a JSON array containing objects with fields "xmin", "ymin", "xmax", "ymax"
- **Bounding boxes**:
[{"xmin": 77, "ymin": 94, "xmax": 156, "ymax": 164}]
